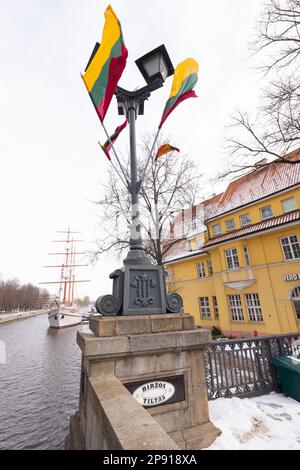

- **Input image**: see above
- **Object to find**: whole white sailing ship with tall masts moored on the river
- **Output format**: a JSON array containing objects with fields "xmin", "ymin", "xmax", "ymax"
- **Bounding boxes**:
[{"xmin": 40, "ymin": 228, "xmax": 89, "ymax": 328}]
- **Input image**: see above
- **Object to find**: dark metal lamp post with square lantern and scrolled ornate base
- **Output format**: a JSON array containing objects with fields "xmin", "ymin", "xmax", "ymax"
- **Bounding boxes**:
[{"xmin": 96, "ymin": 45, "xmax": 182, "ymax": 315}]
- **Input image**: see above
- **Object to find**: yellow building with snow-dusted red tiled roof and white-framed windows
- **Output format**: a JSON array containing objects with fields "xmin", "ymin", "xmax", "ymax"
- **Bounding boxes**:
[{"xmin": 165, "ymin": 151, "xmax": 300, "ymax": 337}]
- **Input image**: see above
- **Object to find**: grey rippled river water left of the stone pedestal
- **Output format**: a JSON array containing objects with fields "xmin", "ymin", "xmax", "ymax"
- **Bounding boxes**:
[{"xmin": 0, "ymin": 315, "xmax": 88, "ymax": 449}]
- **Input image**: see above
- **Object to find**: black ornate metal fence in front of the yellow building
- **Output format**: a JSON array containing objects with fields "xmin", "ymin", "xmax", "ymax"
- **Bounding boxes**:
[{"xmin": 204, "ymin": 333, "xmax": 300, "ymax": 400}]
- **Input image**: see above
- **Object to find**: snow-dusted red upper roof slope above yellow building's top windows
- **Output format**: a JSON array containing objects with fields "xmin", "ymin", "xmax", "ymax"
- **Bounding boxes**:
[{"xmin": 204, "ymin": 149, "xmax": 300, "ymax": 220}]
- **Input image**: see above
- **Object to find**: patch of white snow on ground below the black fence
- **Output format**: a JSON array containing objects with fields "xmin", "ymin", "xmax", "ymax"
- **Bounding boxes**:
[{"xmin": 208, "ymin": 393, "xmax": 300, "ymax": 450}]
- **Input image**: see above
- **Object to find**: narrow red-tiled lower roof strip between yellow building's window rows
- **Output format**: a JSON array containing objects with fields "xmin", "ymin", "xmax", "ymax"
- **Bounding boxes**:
[{"xmin": 203, "ymin": 209, "xmax": 300, "ymax": 248}]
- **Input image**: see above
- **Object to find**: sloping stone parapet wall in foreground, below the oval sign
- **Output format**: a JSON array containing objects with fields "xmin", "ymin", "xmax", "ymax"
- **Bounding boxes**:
[{"xmin": 66, "ymin": 376, "xmax": 178, "ymax": 450}]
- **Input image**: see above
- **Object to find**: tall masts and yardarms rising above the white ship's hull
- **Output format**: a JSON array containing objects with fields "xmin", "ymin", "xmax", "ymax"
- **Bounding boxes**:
[{"xmin": 39, "ymin": 227, "xmax": 90, "ymax": 306}]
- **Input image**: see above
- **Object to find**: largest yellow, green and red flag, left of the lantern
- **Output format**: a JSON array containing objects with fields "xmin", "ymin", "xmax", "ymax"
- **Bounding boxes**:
[{"xmin": 82, "ymin": 5, "xmax": 128, "ymax": 122}]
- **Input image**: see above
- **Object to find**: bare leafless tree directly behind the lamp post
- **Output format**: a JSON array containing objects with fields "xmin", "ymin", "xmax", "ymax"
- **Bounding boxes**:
[{"xmin": 91, "ymin": 136, "xmax": 200, "ymax": 264}]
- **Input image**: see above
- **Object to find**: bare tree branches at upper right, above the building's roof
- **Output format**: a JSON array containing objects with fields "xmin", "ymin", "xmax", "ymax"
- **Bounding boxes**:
[{"xmin": 225, "ymin": 0, "xmax": 300, "ymax": 174}]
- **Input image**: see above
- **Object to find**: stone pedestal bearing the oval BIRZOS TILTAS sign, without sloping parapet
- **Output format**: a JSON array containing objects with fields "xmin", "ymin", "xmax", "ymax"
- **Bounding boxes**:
[{"xmin": 70, "ymin": 314, "xmax": 220, "ymax": 450}]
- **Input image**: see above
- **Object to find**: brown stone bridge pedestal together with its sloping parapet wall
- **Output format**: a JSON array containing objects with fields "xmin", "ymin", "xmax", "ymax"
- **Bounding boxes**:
[{"xmin": 69, "ymin": 314, "xmax": 220, "ymax": 450}]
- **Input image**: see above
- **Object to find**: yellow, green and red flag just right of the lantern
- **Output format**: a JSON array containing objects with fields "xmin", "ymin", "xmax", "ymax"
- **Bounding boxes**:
[{"xmin": 158, "ymin": 59, "xmax": 199, "ymax": 129}]
